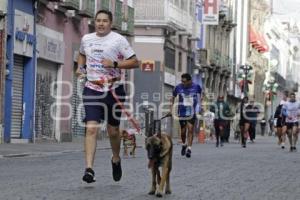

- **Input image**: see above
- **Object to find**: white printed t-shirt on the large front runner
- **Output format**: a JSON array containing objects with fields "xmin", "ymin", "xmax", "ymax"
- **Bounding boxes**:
[{"xmin": 79, "ymin": 31, "xmax": 135, "ymax": 92}]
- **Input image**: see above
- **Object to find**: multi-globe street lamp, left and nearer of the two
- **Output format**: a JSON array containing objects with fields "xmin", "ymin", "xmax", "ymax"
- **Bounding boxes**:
[{"xmin": 238, "ymin": 65, "xmax": 253, "ymax": 97}]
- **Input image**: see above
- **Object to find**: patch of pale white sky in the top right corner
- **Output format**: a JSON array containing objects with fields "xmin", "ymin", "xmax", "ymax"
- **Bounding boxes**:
[{"xmin": 273, "ymin": 0, "xmax": 300, "ymax": 24}]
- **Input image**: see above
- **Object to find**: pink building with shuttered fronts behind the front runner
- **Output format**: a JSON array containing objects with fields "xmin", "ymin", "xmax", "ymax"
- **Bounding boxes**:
[{"xmin": 35, "ymin": 0, "xmax": 134, "ymax": 142}]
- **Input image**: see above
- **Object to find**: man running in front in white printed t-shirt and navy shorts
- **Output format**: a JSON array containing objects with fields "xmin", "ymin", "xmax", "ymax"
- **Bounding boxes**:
[{"xmin": 77, "ymin": 10, "xmax": 138, "ymax": 183}]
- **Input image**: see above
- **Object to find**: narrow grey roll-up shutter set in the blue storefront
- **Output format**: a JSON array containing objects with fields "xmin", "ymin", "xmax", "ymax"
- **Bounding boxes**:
[{"xmin": 11, "ymin": 55, "xmax": 24, "ymax": 138}]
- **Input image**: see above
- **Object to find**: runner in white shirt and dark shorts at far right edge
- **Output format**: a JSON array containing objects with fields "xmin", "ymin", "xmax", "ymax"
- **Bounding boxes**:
[{"xmin": 282, "ymin": 93, "xmax": 300, "ymax": 152}]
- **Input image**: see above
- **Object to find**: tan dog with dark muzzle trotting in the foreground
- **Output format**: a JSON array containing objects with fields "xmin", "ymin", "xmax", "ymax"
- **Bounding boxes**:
[{"xmin": 146, "ymin": 134, "xmax": 173, "ymax": 197}]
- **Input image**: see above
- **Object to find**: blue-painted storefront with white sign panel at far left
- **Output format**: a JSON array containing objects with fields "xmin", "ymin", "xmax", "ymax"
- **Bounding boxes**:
[{"xmin": 4, "ymin": 0, "xmax": 36, "ymax": 142}]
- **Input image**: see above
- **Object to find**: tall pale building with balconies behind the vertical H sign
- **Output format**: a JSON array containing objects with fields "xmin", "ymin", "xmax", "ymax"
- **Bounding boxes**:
[{"xmin": 198, "ymin": 0, "xmax": 236, "ymax": 105}]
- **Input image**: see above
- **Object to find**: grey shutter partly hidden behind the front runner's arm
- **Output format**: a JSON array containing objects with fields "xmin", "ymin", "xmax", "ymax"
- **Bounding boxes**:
[{"xmin": 72, "ymin": 67, "xmax": 85, "ymax": 137}]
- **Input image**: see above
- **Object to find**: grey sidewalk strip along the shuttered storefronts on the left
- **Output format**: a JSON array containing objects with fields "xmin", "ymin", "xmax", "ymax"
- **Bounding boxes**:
[{"xmin": 0, "ymin": 136, "xmax": 144, "ymax": 158}]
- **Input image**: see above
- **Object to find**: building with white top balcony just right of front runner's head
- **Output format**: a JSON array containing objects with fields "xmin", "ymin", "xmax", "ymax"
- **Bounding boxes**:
[{"xmin": 133, "ymin": 0, "xmax": 200, "ymax": 135}]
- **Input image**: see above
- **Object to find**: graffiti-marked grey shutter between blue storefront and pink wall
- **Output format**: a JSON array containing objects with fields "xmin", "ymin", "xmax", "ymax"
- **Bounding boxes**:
[{"xmin": 35, "ymin": 59, "xmax": 58, "ymax": 140}]
